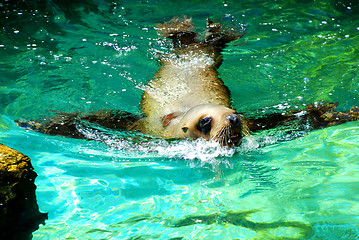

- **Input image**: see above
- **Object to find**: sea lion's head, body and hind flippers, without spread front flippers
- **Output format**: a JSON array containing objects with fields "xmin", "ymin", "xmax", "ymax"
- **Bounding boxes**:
[{"xmin": 134, "ymin": 17, "xmax": 249, "ymax": 145}]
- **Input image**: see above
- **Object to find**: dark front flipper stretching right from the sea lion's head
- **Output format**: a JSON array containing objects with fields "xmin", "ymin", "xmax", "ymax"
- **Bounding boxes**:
[{"xmin": 246, "ymin": 103, "xmax": 359, "ymax": 132}]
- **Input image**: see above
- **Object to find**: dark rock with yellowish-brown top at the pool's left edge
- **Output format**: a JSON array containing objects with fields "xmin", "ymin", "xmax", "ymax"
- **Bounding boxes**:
[{"xmin": 0, "ymin": 144, "xmax": 47, "ymax": 239}]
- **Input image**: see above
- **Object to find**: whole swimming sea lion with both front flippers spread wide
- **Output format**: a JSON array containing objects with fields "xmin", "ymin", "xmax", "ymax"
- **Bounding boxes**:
[{"xmin": 16, "ymin": 17, "xmax": 359, "ymax": 146}]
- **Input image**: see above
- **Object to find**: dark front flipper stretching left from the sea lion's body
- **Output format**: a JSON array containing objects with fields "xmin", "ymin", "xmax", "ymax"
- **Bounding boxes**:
[{"xmin": 15, "ymin": 110, "xmax": 139, "ymax": 139}]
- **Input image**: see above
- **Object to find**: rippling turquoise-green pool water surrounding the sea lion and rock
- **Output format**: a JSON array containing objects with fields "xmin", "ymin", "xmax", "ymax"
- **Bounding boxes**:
[{"xmin": 0, "ymin": 0, "xmax": 359, "ymax": 239}]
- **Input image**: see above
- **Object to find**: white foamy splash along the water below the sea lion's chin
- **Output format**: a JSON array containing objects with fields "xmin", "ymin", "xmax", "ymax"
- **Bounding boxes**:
[{"xmin": 79, "ymin": 124, "xmax": 259, "ymax": 165}]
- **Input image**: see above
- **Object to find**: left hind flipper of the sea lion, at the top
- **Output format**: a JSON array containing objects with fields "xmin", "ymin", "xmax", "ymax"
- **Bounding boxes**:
[{"xmin": 156, "ymin": 16, "xmax": 199, "ymax": 47}]
